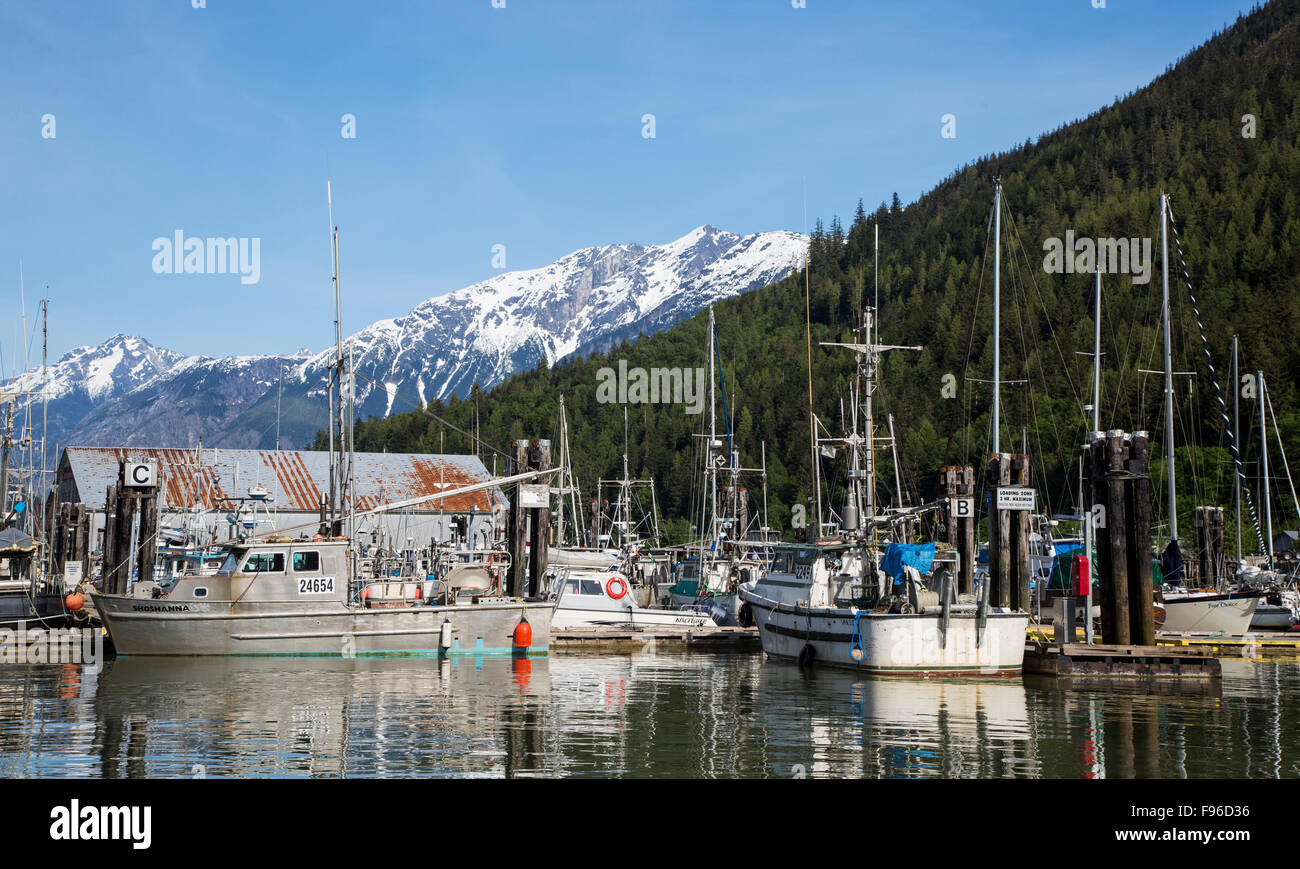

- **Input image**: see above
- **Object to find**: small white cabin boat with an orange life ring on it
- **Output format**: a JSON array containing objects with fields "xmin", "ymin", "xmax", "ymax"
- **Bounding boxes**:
[{"xmin": 551, "ymin": 567, "xmax": 714, "ymax": 630}]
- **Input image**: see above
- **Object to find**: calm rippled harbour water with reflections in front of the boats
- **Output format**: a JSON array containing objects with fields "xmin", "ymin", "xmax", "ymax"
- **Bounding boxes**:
[{"xmin": 0, "ymin": 654, "xmax": 1300, "ymax": 778}]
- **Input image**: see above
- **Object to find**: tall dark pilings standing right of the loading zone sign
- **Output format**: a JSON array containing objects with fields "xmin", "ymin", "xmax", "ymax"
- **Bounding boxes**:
[{"xmin": 1088, "ymin": 429, "xmax": 1156, "ymax": 645}]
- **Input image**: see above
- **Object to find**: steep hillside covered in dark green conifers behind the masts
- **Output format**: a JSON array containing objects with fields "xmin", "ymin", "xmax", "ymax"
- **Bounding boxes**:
[{"xmin": 317, "ymin": 0, "xmax": 1300, "ymax": 545}]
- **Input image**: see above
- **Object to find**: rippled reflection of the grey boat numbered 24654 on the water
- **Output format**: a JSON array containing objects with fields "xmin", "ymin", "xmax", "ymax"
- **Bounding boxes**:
[{"xmin": 94, "ymin": 656, "xmax": 551, "ymax": 778}]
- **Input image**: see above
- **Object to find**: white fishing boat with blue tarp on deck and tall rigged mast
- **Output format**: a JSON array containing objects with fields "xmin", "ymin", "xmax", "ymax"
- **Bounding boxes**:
[{"xmin": 741, "ymin": 201, "xmax": 1030, "ymax": 676}]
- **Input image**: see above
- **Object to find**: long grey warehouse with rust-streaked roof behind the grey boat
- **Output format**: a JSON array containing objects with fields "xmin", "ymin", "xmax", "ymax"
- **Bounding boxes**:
[{"xmin": 55, "ymin": 446, "xmax": 510, "ymax": 550}]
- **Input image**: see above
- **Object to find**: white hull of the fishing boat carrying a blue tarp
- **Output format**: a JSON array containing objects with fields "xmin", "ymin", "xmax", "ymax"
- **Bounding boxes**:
[{"xmin": 741, "ymin": 589, "xmax": 1030, "ymax": 676}]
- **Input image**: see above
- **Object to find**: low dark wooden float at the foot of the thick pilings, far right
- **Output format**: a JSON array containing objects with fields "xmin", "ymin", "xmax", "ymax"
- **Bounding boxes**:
[{"xmin": 1024, "ymin": 641, "xmax": 1223, "ymax": 679}]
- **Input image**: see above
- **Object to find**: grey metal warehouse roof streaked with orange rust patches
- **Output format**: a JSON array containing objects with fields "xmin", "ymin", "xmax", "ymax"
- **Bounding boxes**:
[{"xmin": 57, "ymin": 446, "xmax": 508, "ymax": 513}]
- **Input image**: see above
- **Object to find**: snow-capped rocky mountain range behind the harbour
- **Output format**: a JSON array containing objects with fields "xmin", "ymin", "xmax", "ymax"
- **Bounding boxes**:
[{"xmin": 0, "ymin": 226, "xmax": 807, "ymax": 449}]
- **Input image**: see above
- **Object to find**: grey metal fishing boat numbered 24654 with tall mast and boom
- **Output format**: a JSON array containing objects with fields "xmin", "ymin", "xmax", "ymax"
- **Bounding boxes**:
[{"xmin": 94, "ymin": 187, "xmax": 554, "ymax": 657}]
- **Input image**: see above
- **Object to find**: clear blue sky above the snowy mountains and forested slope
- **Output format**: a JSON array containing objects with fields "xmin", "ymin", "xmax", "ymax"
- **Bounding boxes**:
[{"xmin": 0, "ymin": 0, "xmax": 1251, "ymax": 366}]
